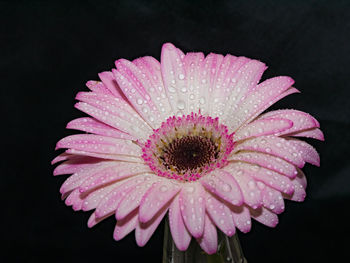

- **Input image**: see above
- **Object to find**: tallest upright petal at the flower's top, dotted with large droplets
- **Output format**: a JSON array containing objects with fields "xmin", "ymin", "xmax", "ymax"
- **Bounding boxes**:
[{"xmin": 160, "ymin": 43, "xmax": 190, "ymax": 115}]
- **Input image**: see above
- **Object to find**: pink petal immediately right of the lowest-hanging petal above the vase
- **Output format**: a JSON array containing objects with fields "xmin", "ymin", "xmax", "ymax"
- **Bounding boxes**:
[{"xmin": 206, "ymin": 193, "xmax": 236, "ymax": 236}]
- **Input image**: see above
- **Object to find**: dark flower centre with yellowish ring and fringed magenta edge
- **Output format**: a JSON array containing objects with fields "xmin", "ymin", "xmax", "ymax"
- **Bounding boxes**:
[{"xmin": 142, "ymin": 113, "xmax": 233, "ymax": 181}]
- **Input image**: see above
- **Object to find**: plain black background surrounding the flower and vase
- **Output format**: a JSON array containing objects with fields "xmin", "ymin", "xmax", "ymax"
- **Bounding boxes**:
[{"xmin": 0, "ymin": 0, "xmax": 350, "ymax": 262}]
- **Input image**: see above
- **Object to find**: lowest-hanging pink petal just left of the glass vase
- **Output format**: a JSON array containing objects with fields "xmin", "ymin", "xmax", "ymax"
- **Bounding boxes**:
[{"xmin": 135, "ymin": 207, "xmax": 168, "ymax": 247}]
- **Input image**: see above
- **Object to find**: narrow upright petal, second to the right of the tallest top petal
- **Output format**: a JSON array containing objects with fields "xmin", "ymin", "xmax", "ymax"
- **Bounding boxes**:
[{"xmin": 197, "ymin": 53, "xmax": 224, "ymax": 114}]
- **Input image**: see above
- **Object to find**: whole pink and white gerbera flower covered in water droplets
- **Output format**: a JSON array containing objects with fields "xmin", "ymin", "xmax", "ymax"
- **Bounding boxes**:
[{"xmin": 53, "ymin": 43, "xmax": 323, "ymax": 254}]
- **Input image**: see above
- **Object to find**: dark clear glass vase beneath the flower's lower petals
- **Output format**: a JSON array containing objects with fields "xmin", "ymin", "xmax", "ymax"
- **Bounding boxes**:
[{"xmin": 162, "ymin": 220, "xmax": 247, "ymax": 263}]
